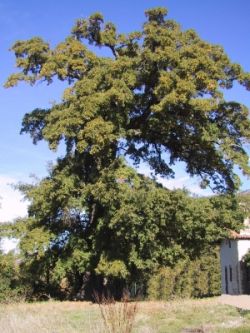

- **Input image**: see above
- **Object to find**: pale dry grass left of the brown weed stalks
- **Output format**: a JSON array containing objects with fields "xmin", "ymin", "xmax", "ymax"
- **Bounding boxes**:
[{"xmin": 0, "ymin": 302, "xmax": 103, "ymax": 333}]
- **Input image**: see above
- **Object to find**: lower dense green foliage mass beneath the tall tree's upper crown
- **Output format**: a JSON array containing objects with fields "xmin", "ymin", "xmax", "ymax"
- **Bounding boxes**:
[{"xmin": 2, "ymin": 161, "xmax": 243, "ymax": 298}]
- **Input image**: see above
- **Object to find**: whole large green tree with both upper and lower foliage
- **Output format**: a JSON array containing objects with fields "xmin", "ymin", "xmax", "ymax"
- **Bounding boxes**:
[{"xmin": 6, "ymin": 8, "xmax": 250, "ymax": 293}]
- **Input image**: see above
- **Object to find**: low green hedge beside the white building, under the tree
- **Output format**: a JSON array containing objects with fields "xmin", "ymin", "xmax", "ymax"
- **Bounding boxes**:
[{"xmin": 147, "ymin": 248, "xmax": 221, "ymax": 300}]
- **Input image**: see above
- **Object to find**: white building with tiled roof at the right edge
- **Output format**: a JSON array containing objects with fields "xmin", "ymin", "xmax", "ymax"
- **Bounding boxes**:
[{"xmin": 220, "ymin": 219, "xmax": 250, "ymax": 295}]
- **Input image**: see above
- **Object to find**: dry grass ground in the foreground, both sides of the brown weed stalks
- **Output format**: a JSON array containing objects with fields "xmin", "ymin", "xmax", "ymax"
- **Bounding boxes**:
[{"xmin": 0, "ymin": 298, "xmax": 250, "ymax": 333}]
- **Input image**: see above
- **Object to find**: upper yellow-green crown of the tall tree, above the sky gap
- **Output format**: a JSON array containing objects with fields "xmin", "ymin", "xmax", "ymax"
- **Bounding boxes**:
[{"xmin": 6, "ymin": 8, "xmax": 250, "ymax": 192}]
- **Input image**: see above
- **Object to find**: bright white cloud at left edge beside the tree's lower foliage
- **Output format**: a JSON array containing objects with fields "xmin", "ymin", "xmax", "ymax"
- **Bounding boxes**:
[{"xmin": 0, "ymin": 174, "xmax": 28, "ymax": 222}]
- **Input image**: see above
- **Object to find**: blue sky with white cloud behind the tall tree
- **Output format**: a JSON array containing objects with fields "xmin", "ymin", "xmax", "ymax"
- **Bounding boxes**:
[{"xmin": 0, "ymin": 0, "xmax": 250, "ymax": 221}]
